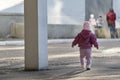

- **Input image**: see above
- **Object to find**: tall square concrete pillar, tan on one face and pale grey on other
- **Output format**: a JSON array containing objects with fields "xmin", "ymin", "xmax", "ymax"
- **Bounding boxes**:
[{"xmin": 24, "ymin": 0, "xmax": 48, "ymax": 70}]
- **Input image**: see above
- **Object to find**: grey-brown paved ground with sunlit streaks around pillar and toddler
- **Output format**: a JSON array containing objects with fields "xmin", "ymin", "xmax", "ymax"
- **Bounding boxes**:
[{"xmin": 0, "ymin": 40, "xmax": 120, "ymax": 80}]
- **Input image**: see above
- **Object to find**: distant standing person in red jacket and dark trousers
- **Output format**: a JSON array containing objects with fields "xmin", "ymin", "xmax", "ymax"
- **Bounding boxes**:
[{"xmin": 106, "ymin": 8, "xmax": 116, "ymax": 38}]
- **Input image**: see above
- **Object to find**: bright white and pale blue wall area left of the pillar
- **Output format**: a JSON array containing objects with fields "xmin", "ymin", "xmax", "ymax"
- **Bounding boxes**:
[{"xmin": 0, "ymin": 0, "xmax": 24, "ymax": 13}]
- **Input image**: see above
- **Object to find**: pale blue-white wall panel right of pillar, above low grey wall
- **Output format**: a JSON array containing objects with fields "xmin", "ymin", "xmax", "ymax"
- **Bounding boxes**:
[{"xmin": 48, "ymin": 0, "xmax": 85, "ymax": 24}]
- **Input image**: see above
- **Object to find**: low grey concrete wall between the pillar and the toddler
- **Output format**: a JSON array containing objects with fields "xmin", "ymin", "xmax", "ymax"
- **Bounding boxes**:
[{"xmin": 48, "ymin": 24, "xmax": 82, "ymax": 39}]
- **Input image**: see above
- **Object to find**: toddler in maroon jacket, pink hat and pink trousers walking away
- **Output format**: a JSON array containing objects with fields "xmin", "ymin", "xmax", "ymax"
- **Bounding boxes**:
[{"xmin": 72, "ymin": 21, "xmax": 98, "ymax": 70}]
